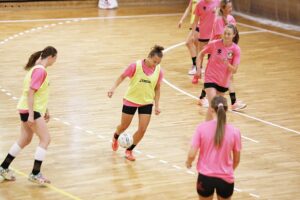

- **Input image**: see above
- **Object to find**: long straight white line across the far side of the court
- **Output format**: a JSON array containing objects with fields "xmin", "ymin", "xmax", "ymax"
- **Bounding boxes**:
[{"xmin": 0, "ymin": 13, "xmax": 182, "ymax": 23}]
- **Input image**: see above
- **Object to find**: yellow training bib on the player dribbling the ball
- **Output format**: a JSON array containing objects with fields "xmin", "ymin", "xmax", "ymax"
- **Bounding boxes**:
[{"xmin": 124, "ymin": 60, "xmax": 160, "ymax": 105}]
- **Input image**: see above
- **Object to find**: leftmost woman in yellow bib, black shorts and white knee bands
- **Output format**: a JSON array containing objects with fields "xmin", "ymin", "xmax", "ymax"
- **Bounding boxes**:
[{"xmin": 0, "ymin": 46, "xmax": 57, "ymax": 184}]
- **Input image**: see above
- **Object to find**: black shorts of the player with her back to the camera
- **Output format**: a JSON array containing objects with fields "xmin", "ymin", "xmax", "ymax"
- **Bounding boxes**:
[{"xmin": 197, "ymin": 173, "xmax": 234, "ymax": 199}]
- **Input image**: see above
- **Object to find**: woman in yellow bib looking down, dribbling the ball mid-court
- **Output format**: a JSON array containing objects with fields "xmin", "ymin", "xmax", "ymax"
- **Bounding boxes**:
[{"xmin": 108, "ymin": 45, "xmax": 164, "ymax": 161}]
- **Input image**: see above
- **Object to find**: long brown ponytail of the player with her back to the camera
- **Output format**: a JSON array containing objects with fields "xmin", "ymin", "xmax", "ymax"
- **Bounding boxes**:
[{"xmin": 211, "ymin": 96, "xmax": 228, "ymax": 147}]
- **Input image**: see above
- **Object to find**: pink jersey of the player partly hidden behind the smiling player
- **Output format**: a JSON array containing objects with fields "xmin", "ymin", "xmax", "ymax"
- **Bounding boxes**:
[{"xmin": 210, "ymin": 15, "xmax": 236, "ymax": 40}]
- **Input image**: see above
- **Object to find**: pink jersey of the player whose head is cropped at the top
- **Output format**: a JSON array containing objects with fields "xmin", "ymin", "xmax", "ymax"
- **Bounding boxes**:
[{"xmin": 194, "ymin": 0, "xmax": 220, "ymax": 39}]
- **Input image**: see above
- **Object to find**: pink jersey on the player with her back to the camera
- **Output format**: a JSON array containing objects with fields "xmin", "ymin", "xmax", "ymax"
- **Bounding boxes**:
[{"xmin": 192, "ymin": 120, "xmax": 242, "ymax": 183}]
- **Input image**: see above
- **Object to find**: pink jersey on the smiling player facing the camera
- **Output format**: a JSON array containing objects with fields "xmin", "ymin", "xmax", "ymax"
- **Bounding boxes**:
[{"xmin": 203, "ymin": 39, "xmax": 241, "ymax": 88}]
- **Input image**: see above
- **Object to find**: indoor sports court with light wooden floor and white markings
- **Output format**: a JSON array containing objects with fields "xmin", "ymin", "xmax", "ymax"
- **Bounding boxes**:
[{"xmin": 0, "ymin": 0, "xmax": 300, "ymax": 200}]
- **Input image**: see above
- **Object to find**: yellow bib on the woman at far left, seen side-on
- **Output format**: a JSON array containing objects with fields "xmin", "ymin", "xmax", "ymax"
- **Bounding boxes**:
[{"xmin": 17, "ymin": 65, "xmax": 49, "ymax": 114}]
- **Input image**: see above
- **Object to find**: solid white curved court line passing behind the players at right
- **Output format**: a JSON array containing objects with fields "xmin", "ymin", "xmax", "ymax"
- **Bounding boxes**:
[{"xmin": 163, "ymin": 42, "xmax": 300, "ymax": 136}]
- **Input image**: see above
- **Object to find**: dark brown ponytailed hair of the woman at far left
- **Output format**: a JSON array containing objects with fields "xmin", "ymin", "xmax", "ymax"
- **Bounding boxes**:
[{"xmin": 24, "ymin": 46, "xmax": 57, "ymax": 71}]
